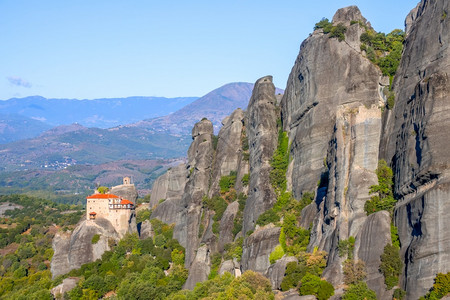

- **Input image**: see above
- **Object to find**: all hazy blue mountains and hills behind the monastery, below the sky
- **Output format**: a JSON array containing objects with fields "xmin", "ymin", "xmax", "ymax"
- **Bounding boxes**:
[{"xmin": 0, "ymin": 82, "xmax": 282, "ymax": 197}]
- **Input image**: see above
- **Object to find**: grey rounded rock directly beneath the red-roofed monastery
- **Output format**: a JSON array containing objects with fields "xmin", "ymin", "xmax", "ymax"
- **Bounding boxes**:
[{"xmin": 50, "ymin": 219, "xmax": 120, "ymax": 278}]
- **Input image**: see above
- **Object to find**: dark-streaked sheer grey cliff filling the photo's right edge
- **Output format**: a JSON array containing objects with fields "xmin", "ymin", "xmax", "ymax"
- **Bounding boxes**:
[{"xmin": 382, "ymin": 0, "xmax": 450, "ymax": 299}]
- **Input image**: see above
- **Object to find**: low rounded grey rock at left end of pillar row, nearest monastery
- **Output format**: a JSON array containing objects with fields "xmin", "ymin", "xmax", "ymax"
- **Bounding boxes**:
[{"xmin": 150, "ymin": 164, "xmax": 189, "ymax": 208}]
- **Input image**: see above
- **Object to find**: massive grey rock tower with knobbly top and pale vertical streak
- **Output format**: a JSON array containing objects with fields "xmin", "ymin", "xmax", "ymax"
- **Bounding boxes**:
[{"xmin": 281, "ymin": 6, "xmax": 390, "ymax": 292}]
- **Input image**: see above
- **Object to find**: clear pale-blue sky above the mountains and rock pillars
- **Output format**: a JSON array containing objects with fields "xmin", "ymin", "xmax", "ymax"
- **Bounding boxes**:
[{"xmin": 0, "ymin": 0, "xmax": 417, "ymax": 100}]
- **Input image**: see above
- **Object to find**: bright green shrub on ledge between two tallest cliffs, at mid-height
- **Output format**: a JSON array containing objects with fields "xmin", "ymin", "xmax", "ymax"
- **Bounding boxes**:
[{"xmin": 364, "ymin": 160, "xmax": 396, "ymax": 215}]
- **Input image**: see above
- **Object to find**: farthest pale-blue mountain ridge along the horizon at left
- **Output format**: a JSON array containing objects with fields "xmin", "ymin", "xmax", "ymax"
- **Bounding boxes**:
[{"xmin": 0, "ymin": 96, "xmax": 198, "ymax": 143}]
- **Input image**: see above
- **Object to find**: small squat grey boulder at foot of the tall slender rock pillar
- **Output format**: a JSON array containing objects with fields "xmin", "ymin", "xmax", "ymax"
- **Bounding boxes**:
[{"xmin": 241, "ymin": 225, "xmax": 280, "ymax": 274}]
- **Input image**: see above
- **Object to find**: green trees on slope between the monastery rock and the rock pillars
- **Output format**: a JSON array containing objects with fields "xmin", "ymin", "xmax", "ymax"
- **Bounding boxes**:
[{"xmin": 65, "ymin": 219, "xmax": 188, "ymax": 299}]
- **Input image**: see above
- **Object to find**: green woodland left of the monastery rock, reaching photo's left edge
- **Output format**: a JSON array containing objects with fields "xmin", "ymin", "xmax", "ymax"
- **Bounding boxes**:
[{"xmin": 0, "ymin": 195, "xmax": 83, "ymax": 299}]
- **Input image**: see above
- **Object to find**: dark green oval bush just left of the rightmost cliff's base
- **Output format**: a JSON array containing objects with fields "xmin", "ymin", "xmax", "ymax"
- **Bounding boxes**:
[{"xmin": 380, "ymin": 244, "xmax": 403, "ymax": 290}]
